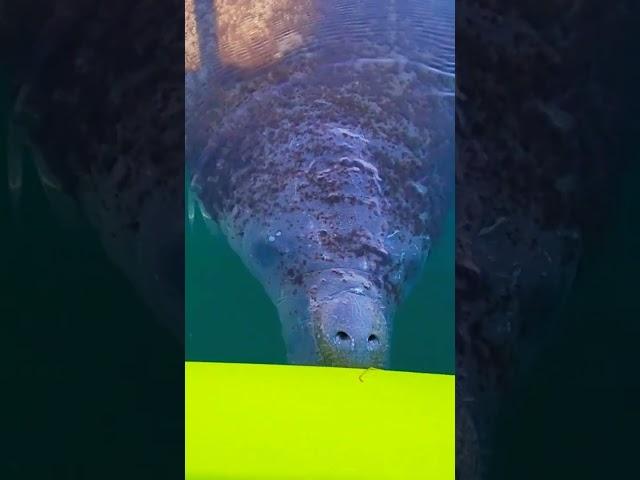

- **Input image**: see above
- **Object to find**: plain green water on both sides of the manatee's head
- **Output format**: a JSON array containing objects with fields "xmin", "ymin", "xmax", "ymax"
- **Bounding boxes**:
[{"xmin": 185, "ymin": 195, "xmax": 455, "ymax": 373}]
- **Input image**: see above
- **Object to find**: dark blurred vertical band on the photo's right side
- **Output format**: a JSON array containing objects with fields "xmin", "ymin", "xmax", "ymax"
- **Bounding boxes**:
[{"xmin": 456, "ymin": 0, "xmax": 640, "ymax": 480}]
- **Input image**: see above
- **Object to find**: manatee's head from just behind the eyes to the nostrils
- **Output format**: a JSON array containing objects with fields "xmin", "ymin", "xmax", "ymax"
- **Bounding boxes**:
[{"xmin": 222, "ymin": 193, "xmax": 424, "ymax": 367}]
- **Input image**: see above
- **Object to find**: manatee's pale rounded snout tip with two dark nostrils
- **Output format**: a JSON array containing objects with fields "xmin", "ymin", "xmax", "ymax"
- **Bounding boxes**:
[{"xmin": 310, "ymin": 291, "xmax": 390, "ymax": 367}]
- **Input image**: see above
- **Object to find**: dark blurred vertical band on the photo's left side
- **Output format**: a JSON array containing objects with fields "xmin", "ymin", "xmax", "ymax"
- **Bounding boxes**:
[{"xmin": 0, "ymin": 0, "xmax": 184, "ymax": 479}]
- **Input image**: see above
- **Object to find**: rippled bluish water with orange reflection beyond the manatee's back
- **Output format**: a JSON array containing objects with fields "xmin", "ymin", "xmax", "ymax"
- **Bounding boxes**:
[{"xmin": 185, "ymin": 0, "xmax": 455, "ymax": 175}]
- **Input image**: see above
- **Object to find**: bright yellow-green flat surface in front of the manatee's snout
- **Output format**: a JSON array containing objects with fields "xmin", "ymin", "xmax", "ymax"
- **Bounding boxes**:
[{"xmin": 185, "ymin": 362, "xmax": 455, "ymax": 480}]
